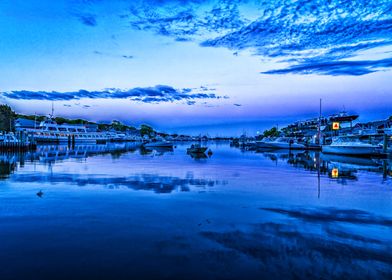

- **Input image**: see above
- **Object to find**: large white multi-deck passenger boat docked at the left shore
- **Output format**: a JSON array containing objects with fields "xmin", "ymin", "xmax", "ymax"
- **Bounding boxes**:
[{"xmin": 26, "ymin": 118, "xmax": 111, "ymax": 143}]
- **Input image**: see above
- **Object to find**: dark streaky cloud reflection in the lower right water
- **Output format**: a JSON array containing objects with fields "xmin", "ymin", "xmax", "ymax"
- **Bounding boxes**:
[{"xmin": 201, "ymin": 208, "xmax": 392, "ymax": 279}]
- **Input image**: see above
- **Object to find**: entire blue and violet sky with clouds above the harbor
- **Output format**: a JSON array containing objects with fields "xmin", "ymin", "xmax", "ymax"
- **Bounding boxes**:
[{"xmin": 0, "ymin": 0, "xmax": 392, "ymax": 135}]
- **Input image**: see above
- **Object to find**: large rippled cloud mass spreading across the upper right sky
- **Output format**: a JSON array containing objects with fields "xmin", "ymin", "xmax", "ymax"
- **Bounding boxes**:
[{"xmin": 118, "ymin": 0, "xmax": 392, "ymax": 75}]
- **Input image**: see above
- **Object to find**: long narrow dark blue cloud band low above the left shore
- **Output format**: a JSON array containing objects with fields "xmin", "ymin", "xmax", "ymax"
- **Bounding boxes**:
[{"xmin": 1, "ymin": 85, "xmax": 227, "ymax": 105}]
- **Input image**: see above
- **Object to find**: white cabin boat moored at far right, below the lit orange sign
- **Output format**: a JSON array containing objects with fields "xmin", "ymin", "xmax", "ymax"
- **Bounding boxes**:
[{"xmin": 322, "ymin": 136, "xmax": 382, "ymax": 156}]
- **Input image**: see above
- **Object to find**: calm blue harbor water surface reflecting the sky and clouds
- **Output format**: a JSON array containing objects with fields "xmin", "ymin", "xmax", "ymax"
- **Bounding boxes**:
[{"xmin": 0, "ymin": 143, "xmax": 392, "ymax": 279}]
